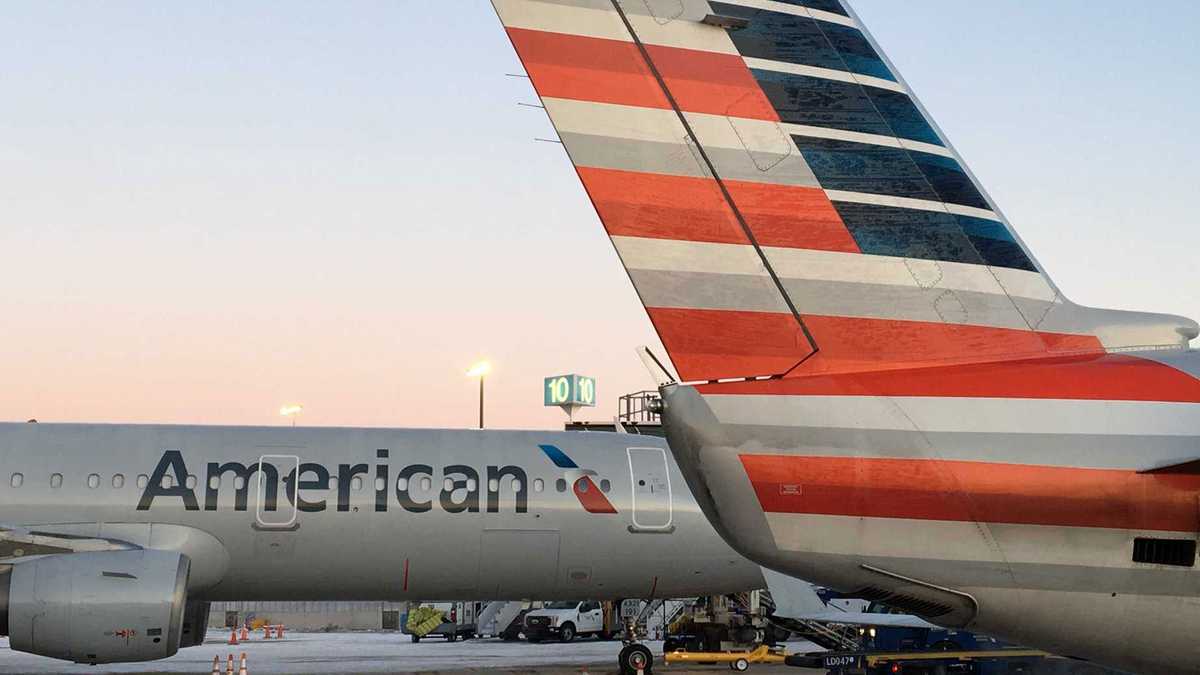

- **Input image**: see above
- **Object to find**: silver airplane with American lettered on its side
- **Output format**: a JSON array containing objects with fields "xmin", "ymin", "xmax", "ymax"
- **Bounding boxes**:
[{"xmin": 0, "ymin": 423, "xmax": 764, "ymax": 664}]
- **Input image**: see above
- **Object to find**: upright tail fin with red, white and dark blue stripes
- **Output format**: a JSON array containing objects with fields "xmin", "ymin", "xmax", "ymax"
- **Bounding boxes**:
[{"xmin": 493, "ymin": 0, "xmax": 1200, "ymax": 381}]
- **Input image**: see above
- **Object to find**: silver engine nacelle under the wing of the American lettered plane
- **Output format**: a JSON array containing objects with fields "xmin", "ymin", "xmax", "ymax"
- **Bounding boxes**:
[{"xmin": 0, "ymin": 550, "xmax": 191, "ymax": 664}]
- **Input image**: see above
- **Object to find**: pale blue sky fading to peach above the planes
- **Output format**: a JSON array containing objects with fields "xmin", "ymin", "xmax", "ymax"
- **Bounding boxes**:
[{"xmin": 0, "ymin": 0, "xmax": 1200, "ymax": 429}]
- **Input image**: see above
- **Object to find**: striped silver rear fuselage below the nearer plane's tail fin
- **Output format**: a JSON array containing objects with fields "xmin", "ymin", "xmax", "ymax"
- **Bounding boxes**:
[{"xmin": 664, "ymin": 351, "xmax": 1200, "ymax": 675}]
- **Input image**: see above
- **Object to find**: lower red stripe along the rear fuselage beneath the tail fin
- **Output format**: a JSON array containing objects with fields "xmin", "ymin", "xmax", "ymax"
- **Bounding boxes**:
[{"xmin": 742, "ymin": 455, "xmax": 1200, "ymax": 532}]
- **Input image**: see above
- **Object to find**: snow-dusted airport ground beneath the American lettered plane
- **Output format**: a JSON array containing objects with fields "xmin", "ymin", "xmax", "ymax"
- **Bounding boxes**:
[{"xmin": 0, "ymin": 632, "xmax": 820, "ymax": 675}]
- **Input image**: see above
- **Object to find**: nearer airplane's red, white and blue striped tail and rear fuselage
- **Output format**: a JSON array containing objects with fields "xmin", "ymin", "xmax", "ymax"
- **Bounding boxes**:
[{"xmin": 492, "ymin": 0, "xmax": 1200, "ymax": 674}]
